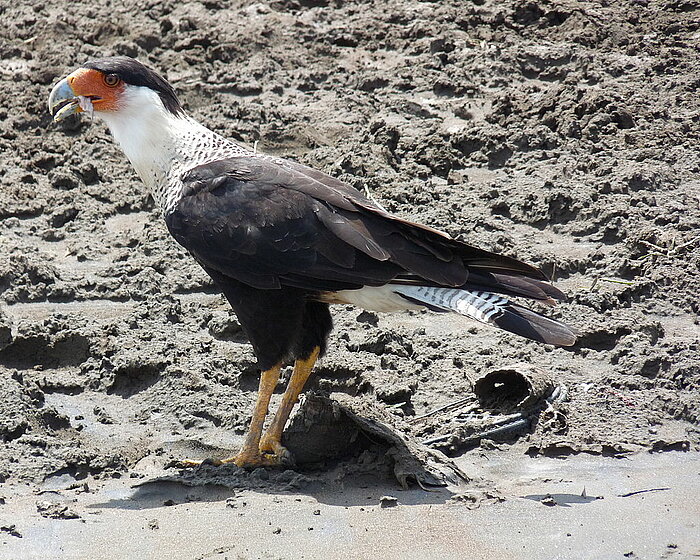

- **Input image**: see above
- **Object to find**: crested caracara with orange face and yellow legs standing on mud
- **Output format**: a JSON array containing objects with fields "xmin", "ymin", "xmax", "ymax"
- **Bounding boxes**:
[{"xmin": 48, "ymin": 56, "xmax": 577, "ymax": 469}]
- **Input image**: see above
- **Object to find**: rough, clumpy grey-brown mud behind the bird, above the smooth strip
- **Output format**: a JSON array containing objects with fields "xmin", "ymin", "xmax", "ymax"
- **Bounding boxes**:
[{"xmin": 0, "ymin": 0, "xmax": 700, "ymax": 558}]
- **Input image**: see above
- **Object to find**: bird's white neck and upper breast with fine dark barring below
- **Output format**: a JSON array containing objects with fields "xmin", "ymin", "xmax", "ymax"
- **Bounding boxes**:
[{"xmin": 95, "ymin": 86, "xmax": 248, "ymax": 213}]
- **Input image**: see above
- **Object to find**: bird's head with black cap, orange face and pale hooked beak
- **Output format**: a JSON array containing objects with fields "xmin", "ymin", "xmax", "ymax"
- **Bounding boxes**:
[{"xmin": 49, "ymin": 56, "xmax": 183, "ymax": 121}]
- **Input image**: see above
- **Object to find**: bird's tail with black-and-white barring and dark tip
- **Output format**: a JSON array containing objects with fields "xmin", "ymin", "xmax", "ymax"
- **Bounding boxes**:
[{"xmin": 391, "ymin": 284, "xmax": 576, "ymax": 346}]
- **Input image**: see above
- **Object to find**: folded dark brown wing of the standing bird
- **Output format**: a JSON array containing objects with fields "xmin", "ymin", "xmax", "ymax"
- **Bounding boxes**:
[{"xmin": 166, "ymin": 156, "xmax": 563, "ymax": 299}]
